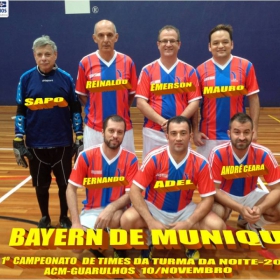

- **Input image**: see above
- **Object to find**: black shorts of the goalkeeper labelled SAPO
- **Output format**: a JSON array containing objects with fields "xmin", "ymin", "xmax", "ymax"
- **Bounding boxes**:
[{"xmin": 29, "ymin": 146, "xmax": 72, "ymax": 186}]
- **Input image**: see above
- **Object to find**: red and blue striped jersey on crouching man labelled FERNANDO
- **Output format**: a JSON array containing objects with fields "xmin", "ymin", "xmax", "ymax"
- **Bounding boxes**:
[{"xmin": 69, "ymin": 144, "xmax": 138, "ymax": 210}]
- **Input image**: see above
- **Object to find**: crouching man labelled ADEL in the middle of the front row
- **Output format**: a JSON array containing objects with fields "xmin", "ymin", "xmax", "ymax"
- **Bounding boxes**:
[{"xmin": 121, "ymin": 116, "xmax": 225, "ymax": 259}]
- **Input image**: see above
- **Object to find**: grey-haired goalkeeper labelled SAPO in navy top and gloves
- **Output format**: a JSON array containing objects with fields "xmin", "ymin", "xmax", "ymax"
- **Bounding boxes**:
[{"xmin": 13, "ymin": 35, "xmax": 83, "ymax": 228}]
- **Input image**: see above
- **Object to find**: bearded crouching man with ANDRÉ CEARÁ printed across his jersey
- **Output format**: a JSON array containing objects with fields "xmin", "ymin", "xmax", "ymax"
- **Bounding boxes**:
[{"xmin": 209, "ymin": 113, "xmax": 280, "ymax": 242}]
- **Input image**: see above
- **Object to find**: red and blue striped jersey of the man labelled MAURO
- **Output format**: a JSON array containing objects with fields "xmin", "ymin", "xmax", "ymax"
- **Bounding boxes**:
[{"xmin": 197, "ymin": 56, "xmax": 259, "ymax": 140}]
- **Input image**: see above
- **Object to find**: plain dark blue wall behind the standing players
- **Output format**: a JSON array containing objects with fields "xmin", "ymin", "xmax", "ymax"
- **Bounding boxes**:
[{"xmin": 0, "ymin": 1, "xmax": 280, "ymax": 107}]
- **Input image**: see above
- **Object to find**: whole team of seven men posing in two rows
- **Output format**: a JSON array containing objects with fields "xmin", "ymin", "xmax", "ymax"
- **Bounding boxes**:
[{"xmin": 13, "ymin": 20, "xmax": 280, "ymax": 260}]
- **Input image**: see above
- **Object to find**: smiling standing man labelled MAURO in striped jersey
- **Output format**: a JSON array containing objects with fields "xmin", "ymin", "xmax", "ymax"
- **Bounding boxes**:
[{"xmin": 193, "ymin": 24, "xmax": 260, "ymax": 158}]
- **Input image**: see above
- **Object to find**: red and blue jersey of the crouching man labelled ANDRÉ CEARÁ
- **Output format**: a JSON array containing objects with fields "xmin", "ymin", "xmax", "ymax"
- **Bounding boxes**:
[{"xmin": 209, "ymin": 142, "xmax": 280, "ymax": 196}]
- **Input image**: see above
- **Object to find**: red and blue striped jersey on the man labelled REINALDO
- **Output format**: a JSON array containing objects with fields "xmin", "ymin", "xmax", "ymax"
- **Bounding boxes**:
[{"xmin": 76, "ymin": 51, "xmax": 137, "ymax": 131}]
